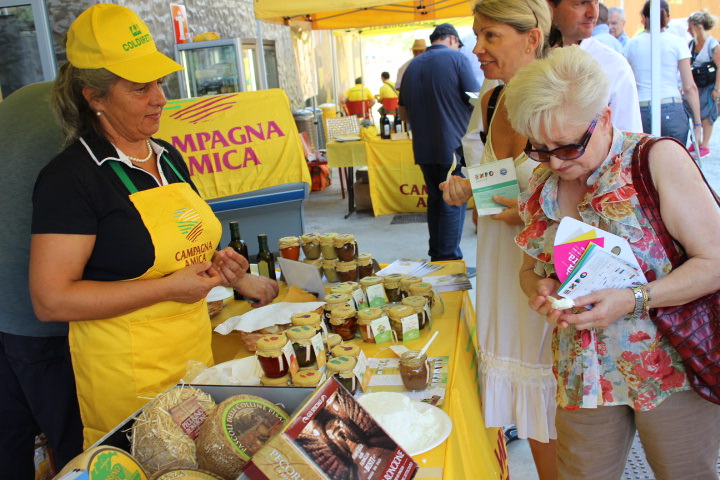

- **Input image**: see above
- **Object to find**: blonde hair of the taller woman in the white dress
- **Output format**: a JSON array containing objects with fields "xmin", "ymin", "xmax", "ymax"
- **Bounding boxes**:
[{"xmin": 473, "ymin": 0, "xmax": 552, "ymax": 58}]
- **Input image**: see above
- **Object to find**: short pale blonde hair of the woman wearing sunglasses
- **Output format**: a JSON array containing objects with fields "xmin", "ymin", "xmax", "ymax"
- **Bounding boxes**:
[{"xmin": 505, "ymin": 45, "xmax": 610, "ymax": 139}]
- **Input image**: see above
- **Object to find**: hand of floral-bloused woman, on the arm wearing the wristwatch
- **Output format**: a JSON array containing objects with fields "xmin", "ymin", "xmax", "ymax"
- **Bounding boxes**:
[{"xmin": 560, "ymin": 288, "xmax": 635, "ymax": 330}]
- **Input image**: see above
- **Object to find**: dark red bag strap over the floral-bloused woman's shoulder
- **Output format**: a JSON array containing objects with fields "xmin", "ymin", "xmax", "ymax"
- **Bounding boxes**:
[{"xmin": 632, "ymin": 135, "xmax": 720, "ymax": 269}]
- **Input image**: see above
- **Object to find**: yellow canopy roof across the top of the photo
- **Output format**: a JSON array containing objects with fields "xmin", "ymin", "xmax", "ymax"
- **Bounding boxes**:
[{"xmin": 254, "ymin": 0, "xmax": 474, "ymax": 30}]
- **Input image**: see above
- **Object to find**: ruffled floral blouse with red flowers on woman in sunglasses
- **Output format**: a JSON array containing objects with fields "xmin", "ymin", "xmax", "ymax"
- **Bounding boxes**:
[{"xmin": 516, "ymin": 129, "xmax": 690, "ymax": 411}]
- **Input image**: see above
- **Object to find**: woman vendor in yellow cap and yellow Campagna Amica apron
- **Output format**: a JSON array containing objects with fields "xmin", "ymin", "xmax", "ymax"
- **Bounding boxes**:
[{"xmin": 30, "ymin": 4, "xmax": 277, "ymax": 447}]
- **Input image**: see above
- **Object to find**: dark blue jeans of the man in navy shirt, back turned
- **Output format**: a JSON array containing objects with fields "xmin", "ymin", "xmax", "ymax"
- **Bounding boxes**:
[{"xmin": 419, "ymin": 159, "xmax": 467, "ymax": 262}]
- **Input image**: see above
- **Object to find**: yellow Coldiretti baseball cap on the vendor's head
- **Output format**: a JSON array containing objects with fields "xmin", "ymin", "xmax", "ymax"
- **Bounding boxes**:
[{"xmin": 66, "ymin": 3, "xmax": 183, "ymax": 83}]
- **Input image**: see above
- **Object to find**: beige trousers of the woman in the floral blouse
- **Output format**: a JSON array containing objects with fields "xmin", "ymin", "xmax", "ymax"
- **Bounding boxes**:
[{"xmin": 555, "ymin": 391, "xmax": 720, "ymax": 480}]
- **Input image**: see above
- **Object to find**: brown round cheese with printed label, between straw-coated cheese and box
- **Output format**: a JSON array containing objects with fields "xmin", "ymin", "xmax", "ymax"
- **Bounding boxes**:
[{"xmin": 195, "ymin": 395, "xmax": 288, "ymax": 480}]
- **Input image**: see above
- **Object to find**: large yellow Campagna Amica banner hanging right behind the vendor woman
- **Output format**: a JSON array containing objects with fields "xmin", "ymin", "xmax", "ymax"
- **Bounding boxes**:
[{"xmin": 157, "ymin": 89, "xmax": 310, "ymax": 200}]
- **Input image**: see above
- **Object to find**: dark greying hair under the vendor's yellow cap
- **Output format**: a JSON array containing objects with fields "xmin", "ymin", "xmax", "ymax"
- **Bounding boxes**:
[{"xmin": 50, "ymin": 63, "xmax": 120, "ymax": 146}]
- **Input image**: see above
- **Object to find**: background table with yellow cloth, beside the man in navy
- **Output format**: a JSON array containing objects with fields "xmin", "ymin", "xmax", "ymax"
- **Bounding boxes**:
[{"xmin": 326, "ymin": 137, "xmax": 427, "ymax": 218}]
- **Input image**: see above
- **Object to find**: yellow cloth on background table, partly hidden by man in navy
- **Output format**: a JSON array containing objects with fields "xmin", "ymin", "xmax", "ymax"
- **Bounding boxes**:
[{"xmin": 366, "ymin": 140, "xmax": 427, "ymax": 215}]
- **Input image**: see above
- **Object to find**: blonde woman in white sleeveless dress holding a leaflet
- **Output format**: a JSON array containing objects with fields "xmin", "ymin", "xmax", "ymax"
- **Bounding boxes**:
[{"xmin": 440, "ymin": 0, "xmax": 557, "ymax": 480}]
